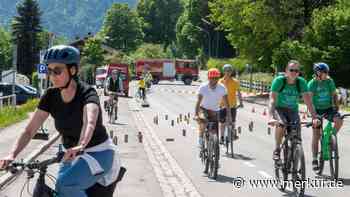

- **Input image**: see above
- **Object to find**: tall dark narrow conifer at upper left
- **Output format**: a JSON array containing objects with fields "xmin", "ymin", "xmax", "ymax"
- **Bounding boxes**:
[{"xmin": 12, "ymin": 0, "xmax": 42, "ymax": 78}]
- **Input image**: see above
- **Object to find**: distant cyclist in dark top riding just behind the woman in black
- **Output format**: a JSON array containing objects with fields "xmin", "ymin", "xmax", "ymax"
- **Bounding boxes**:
[{"xmin": 107, "ymin": 69, "xmax": 123, "ymax": 120}]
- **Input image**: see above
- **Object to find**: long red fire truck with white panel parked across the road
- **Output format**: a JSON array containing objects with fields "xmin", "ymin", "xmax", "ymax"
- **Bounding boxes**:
[{"xmin": 135, "ymin": 59, "xmax": 199, "ymax": 85}]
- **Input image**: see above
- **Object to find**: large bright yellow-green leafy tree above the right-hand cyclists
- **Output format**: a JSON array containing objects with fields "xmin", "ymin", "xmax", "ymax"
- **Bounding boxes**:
[{"xmin": 210, "ymin": 0, "xmax": 336, "ymax": 70}]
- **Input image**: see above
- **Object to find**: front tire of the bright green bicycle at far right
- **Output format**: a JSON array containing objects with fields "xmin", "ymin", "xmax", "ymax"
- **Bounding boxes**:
[{"xmin": 329, "ymin": 135, "xmax": 339, "ymax": 180}]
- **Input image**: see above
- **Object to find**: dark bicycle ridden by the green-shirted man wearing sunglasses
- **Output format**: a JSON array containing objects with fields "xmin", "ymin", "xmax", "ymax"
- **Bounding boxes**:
[{"xmin": 275, "ymin": 122, "xmax": 312, "ymax": 197}]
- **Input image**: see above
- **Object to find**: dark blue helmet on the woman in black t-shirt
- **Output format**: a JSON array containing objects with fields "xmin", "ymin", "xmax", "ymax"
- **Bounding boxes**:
[{"xmin": 44, "ymin": 45, "xmax": 80, "ymax": 65}]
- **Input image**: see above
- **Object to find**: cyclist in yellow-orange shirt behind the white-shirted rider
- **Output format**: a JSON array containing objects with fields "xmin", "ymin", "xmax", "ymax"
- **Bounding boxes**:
[{"xmin": 219, "ymin": 64, "xmax": 243, "ymax": 144}]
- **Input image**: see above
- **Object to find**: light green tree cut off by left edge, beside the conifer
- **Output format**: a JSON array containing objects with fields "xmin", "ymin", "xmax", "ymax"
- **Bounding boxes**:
[{"xmin": 0, "ymin": 27, "xmax": 12, "ymax": 71}]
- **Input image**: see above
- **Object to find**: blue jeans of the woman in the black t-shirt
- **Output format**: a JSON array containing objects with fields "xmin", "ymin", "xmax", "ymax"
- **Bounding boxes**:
[{"xmin": 56, "ymin": 150, "xmax": 114, "ymax": 197}]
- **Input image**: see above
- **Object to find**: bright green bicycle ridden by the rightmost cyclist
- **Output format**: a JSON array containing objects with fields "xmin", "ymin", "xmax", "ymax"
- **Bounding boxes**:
[{"xmin": 316, "ymin": 114, "xmax": 350, "ymax": 180}]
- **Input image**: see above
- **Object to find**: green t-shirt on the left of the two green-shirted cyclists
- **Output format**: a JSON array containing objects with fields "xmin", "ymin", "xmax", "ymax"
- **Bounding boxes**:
[{"xmin": 271, "ymin": 76, "xmax": 308, "ymax": 111}]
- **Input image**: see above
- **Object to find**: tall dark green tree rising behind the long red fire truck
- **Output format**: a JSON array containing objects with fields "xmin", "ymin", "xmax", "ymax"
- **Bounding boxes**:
[{"xmin": 137, "ymin": 0, "xmax": 182, "ymax": 48}]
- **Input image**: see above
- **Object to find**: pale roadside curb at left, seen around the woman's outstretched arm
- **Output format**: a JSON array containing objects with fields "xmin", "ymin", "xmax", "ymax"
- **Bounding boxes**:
[{"xmin": 0, "ymin": 133, "xmax": 60, "ymax": 190}]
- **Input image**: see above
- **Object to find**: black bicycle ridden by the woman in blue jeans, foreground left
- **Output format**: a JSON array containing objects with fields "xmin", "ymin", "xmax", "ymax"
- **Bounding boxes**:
[{"xmin": 1, "ymin": 152, "xmax": 126, "ymax": 197}]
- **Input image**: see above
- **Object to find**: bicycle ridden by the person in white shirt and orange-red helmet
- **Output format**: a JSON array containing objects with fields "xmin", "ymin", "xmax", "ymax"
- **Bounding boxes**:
[{"xmin": 195, "ymin": 113, "xmax": 220, "ymax": 180}]
